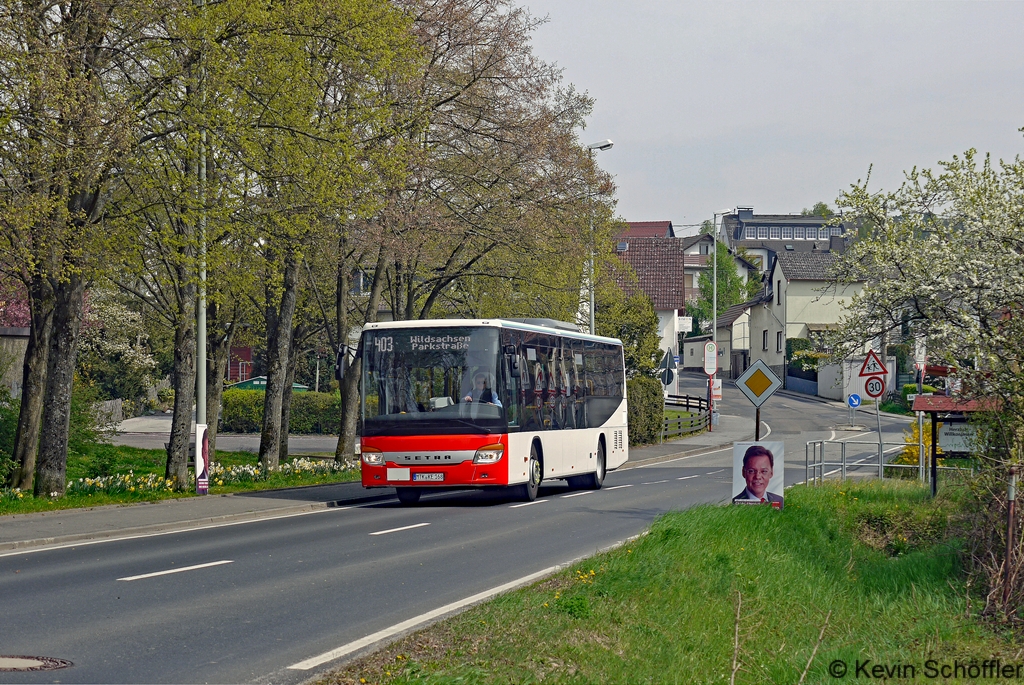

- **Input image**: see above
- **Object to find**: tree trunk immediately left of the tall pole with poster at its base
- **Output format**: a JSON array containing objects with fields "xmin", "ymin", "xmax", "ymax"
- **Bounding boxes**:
[{"xmin": 165, "ymin": 278, "xmax": 198, "ymax": 485}]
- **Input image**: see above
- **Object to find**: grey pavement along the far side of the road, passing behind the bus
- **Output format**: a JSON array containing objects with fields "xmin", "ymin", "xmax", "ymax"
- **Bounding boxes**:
[{"xmin": 0, "ymin": 416, "xmax": 754, "ymax": 552}]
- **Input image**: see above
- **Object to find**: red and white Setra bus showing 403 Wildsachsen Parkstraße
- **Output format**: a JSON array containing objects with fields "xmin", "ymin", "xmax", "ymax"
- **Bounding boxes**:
[{"xmin": 358, "ymin": 319, "xmax": 629, "ymax": 504}]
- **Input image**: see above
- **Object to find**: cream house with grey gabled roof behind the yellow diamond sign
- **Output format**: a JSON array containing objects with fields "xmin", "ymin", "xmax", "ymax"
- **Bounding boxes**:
[{"xmin": 750, "ymin": 250, "xmax": 863, "ymax": 378}]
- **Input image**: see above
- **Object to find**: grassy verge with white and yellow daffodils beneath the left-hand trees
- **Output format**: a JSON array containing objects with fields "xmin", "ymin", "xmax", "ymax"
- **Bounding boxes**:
[{"xmin": 0, "ymin": 443, "xmax": 359, "ymax": 515}]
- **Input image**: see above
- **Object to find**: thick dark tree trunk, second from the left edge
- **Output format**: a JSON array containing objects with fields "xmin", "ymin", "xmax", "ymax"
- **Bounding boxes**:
[{"xmin": 35, "ymin": 273, "xmax": 85, "ymax": 497}]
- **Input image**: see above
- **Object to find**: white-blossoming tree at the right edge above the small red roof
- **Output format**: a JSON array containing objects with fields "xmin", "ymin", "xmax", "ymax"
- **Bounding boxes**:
[{"xmin": 836, "ymin": 149, "xmax": 1024, "ymax": 463}]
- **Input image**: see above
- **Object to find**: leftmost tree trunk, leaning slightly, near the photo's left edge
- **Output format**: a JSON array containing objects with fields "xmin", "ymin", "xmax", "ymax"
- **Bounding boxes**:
[{"xmin": 10, "ymin": 274, "xmax": 54, "ymax": 491}]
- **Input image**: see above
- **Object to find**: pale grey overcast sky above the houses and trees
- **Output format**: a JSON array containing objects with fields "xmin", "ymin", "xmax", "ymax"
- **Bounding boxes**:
[{"xmin": 518, "ymin": 0, "xmax": 1024, "ymax": 232}]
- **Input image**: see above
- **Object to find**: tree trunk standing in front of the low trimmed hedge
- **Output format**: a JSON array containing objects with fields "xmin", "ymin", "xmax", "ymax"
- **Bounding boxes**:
[{"xmin": 259, "ymin": 252, "xmax": 299, "ymax": 474}]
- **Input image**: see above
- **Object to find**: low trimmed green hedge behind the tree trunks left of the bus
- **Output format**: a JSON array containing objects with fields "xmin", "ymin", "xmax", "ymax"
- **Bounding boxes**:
[{"xmin": 220, "ymin": 390, "xmax": 341, "ymax": 434}]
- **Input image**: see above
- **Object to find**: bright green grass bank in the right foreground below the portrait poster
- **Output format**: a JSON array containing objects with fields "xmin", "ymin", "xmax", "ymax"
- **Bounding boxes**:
[{"xmin": 319, "ymin": 481, "xmax": 1017, "ymax": 685}]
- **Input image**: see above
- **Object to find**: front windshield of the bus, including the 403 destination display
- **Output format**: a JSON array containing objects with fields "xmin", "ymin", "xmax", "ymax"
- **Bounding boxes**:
[{"xmin": 361, "ymin": 327, "xmax": 507, "ymax": 436}]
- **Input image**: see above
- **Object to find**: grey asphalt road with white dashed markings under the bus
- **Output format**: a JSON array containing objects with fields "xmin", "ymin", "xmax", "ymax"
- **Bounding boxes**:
[{"xmin": 0, "ymin": 376, "xmax": 906, "ymax": 683}]
